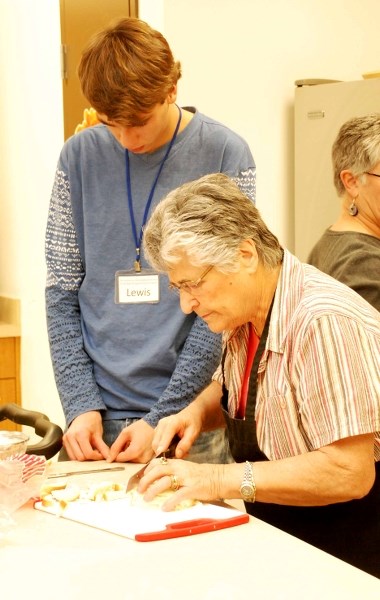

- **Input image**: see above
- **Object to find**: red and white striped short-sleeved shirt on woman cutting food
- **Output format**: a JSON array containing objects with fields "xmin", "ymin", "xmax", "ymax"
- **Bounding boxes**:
[{"xmin": 213, "ymin": 251, "xmax": 380, "ymax": 460}]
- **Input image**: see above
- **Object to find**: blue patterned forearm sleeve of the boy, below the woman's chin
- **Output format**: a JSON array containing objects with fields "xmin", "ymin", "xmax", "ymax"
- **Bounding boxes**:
[{"xmin": 144, "ymin": 317, "xmax": 221, "ymax": 427}]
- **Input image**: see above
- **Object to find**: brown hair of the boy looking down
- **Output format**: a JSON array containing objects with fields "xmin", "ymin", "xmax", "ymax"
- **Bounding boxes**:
[{"xmin": 78, "ymin": 18, "xmax": 181, "ymax": 126}]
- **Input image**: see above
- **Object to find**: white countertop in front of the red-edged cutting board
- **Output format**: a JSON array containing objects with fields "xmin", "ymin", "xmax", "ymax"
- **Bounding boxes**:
[{"xmin": 0, "ymin": 462, "xmax": 380, "ymax": 600}]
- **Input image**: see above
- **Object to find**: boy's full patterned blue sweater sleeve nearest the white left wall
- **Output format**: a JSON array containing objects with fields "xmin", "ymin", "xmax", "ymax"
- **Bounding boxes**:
[{"xmin": 45, "ymin": 168, "xmax": 105, "ymax": 425}]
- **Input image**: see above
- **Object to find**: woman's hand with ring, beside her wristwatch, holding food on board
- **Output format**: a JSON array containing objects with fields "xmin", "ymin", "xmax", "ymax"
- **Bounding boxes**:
[{"xmin": 138, "ymin": 458, "xmax": 225, "ymax": 511}]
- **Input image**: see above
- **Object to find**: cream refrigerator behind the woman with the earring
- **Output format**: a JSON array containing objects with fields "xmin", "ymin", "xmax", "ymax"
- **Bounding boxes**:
[{"xmin": 294, "ymin": 77, "xmax": 380, "ymax": 261}]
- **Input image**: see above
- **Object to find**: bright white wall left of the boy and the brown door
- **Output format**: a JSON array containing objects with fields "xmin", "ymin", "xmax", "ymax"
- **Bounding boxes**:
[{"xmin": 0, "ymin": 0, "xmax": 64, "ymax": 432}]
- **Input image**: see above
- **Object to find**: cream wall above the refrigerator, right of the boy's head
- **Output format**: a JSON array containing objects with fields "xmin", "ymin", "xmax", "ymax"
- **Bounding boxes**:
[{"xmin": 140, "ymin": 0, "xmax": 380, "ymax": 250}]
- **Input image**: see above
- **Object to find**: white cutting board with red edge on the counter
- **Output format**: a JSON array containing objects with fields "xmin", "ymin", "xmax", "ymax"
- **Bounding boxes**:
[{"xmin": 34, "ymin": 498, "xmax": 249, "ymax": 541}]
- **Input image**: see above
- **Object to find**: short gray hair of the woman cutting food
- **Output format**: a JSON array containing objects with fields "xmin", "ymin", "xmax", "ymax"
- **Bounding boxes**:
[{"xmin": 143, "ymin": 173, "xmax": 283, "ymax": 273}]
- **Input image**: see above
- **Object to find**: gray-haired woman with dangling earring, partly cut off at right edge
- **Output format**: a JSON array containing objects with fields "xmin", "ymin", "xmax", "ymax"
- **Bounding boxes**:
[{"xmin": 307, "ymin": 113, "xmax": 380, "ymax": 311}]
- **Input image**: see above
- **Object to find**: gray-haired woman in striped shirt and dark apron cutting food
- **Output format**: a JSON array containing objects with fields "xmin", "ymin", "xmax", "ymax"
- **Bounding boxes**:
[{"xmin": 139, "ymin": 174, "xmax": 380, "ymax": 576}]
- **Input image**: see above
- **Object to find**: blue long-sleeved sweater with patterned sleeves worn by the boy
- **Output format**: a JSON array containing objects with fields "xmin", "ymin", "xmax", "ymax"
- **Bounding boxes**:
[{"xmin": 46, "ymin": 109, "xmax": 255, "ymax": 427}]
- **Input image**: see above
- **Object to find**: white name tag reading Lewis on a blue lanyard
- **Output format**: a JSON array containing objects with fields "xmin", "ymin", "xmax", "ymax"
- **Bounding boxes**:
[{"xmin": 115, "ymin": 270, "xmax": 160, "ymax": 304}]
